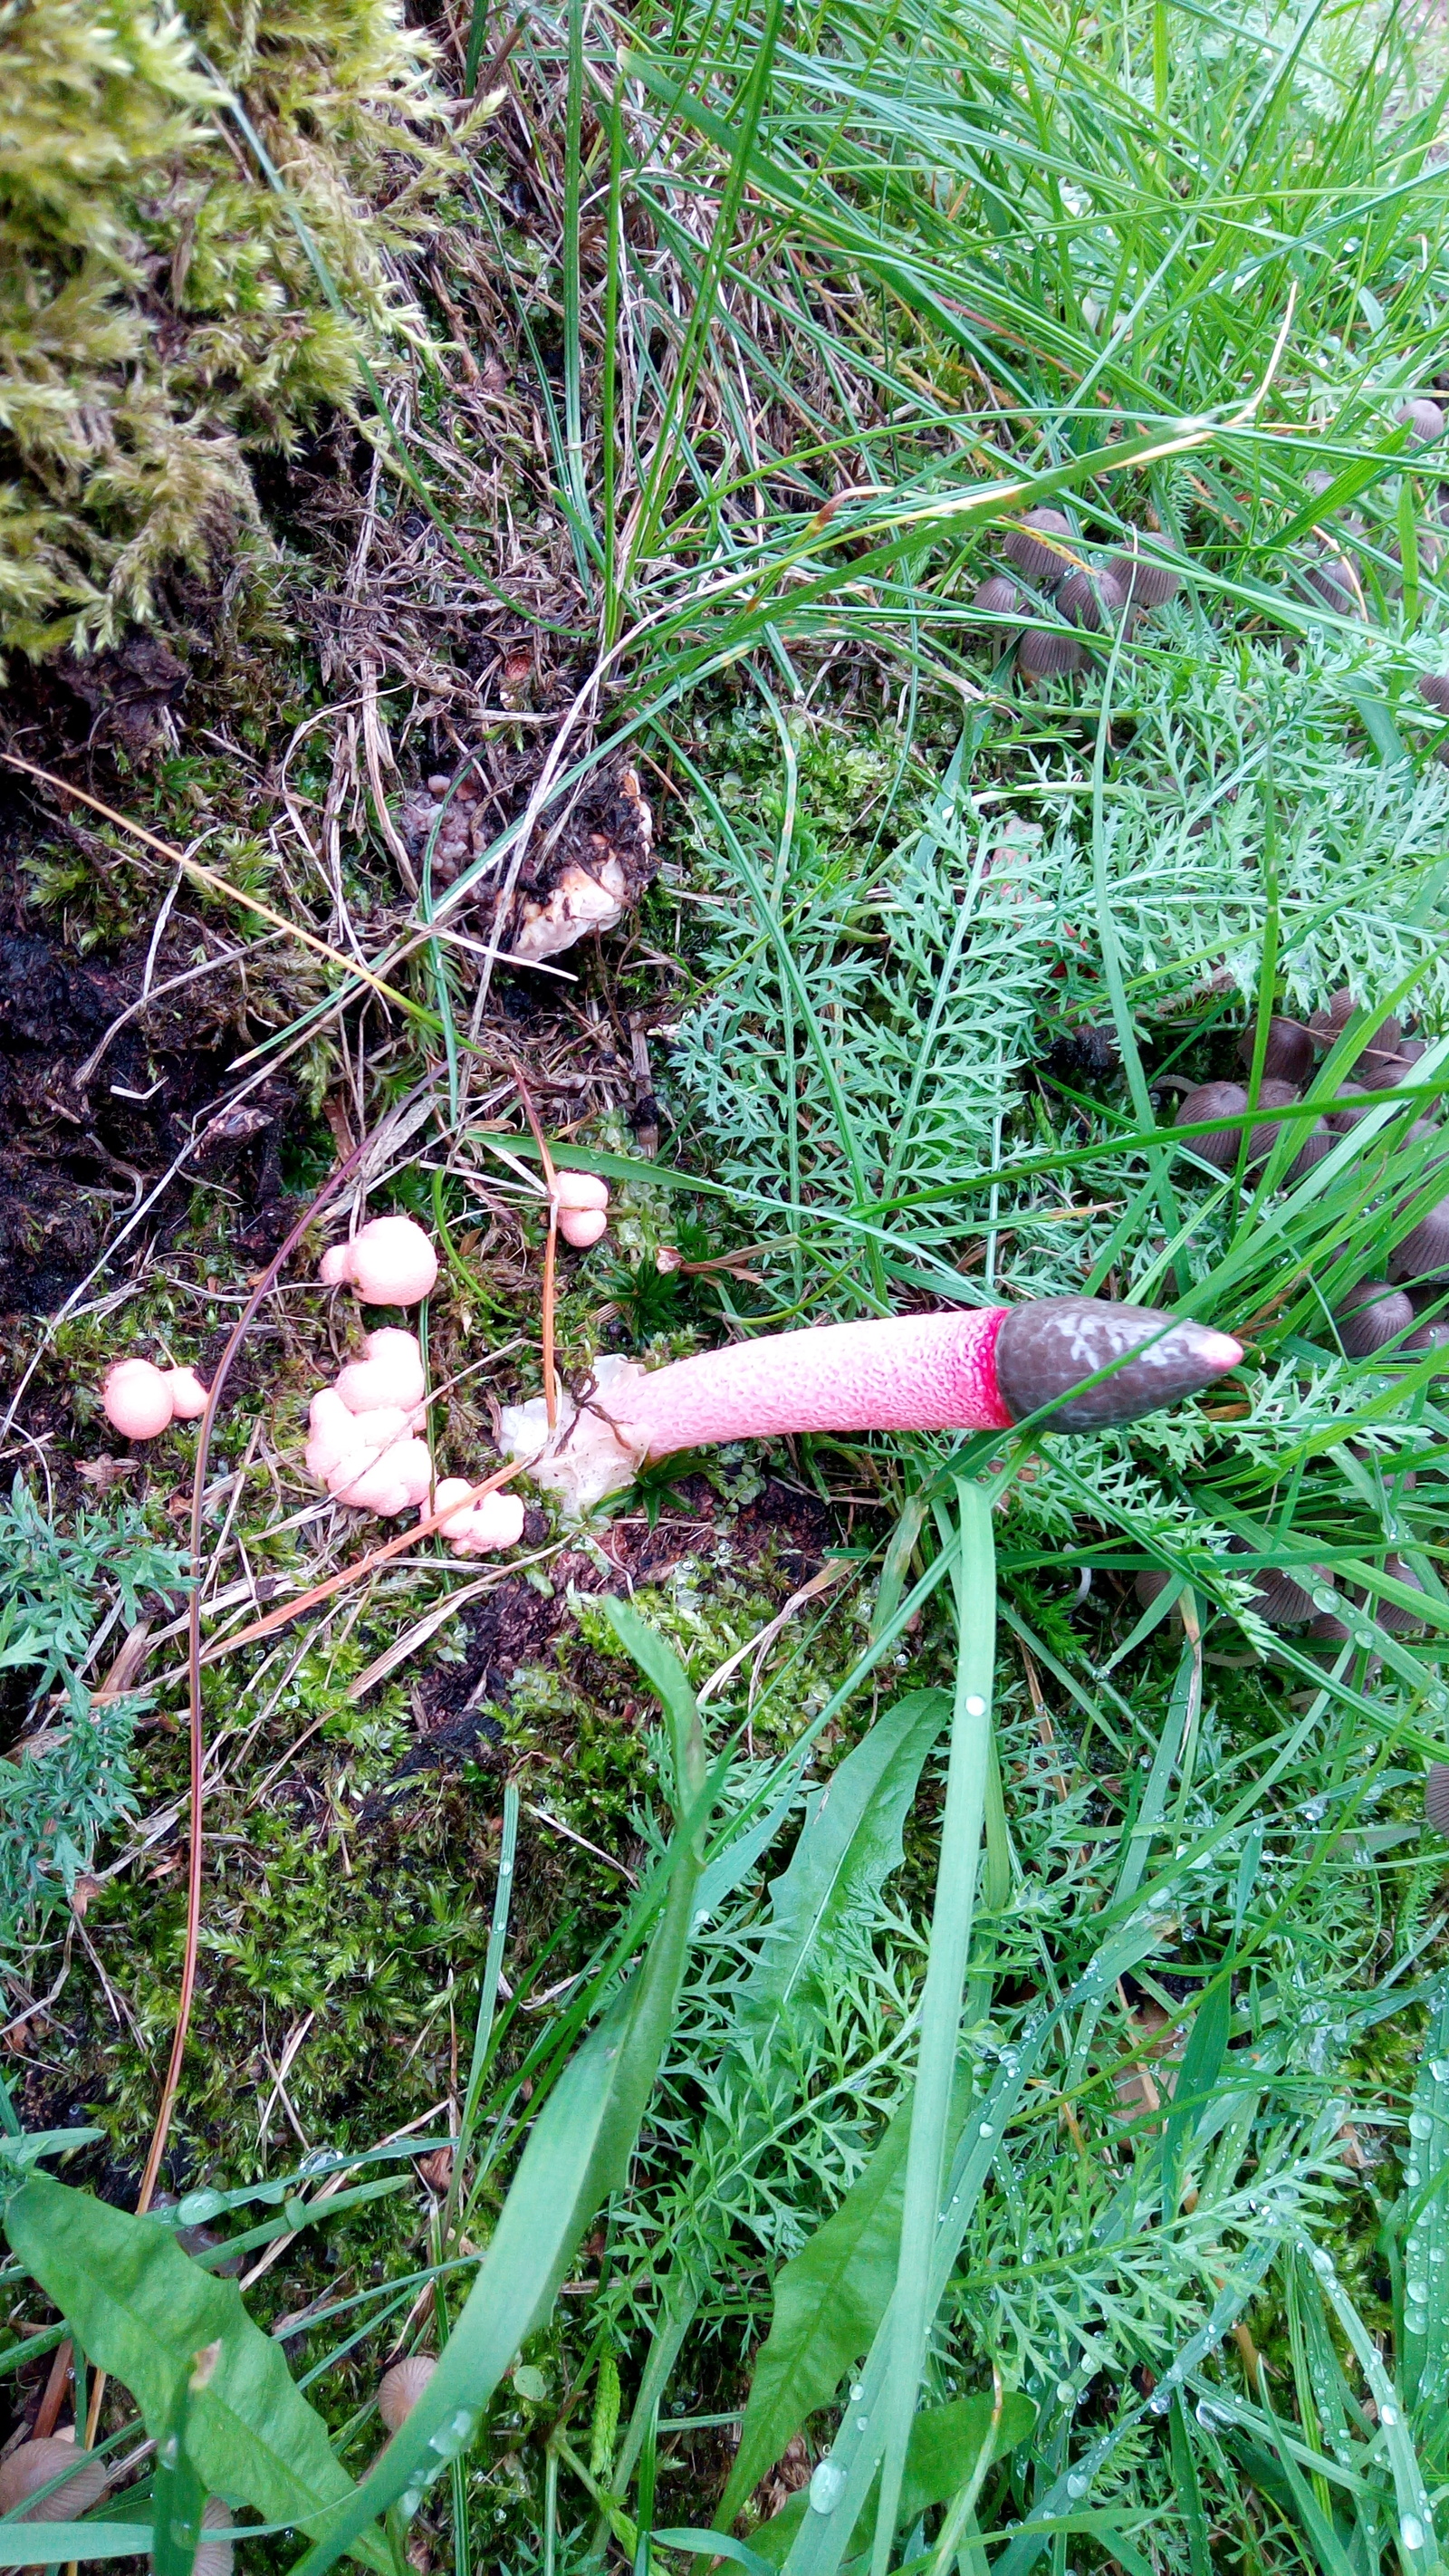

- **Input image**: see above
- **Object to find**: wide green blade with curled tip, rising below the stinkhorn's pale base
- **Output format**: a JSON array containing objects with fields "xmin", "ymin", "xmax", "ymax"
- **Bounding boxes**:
[{"xmin": 293, "ymin": 1605, "xmax": 708, "ymax": 2576}]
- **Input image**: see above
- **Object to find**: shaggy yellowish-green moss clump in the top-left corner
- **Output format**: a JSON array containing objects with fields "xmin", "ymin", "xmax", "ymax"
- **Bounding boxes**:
[{"xmin": 0, "ymin": 0, "xmax": 465, "ymax": 654}]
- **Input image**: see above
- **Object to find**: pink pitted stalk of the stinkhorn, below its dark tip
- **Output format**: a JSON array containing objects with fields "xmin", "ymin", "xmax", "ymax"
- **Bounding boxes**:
[{"xmin": 618, "ymin": 1306, "xmax": 1012, "ymax": 1458}]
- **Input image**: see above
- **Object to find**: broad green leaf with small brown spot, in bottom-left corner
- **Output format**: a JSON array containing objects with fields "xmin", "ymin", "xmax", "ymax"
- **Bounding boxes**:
[{"xmin": 5, "ymin": 2174, "xmax": 380, "ymax": 2568}]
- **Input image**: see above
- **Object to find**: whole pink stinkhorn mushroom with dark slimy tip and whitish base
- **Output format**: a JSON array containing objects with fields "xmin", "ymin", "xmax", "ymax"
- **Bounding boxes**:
[{"xmin": 502, "ymin": 1296, "xmax": 1243, "ymax": 1512}]
